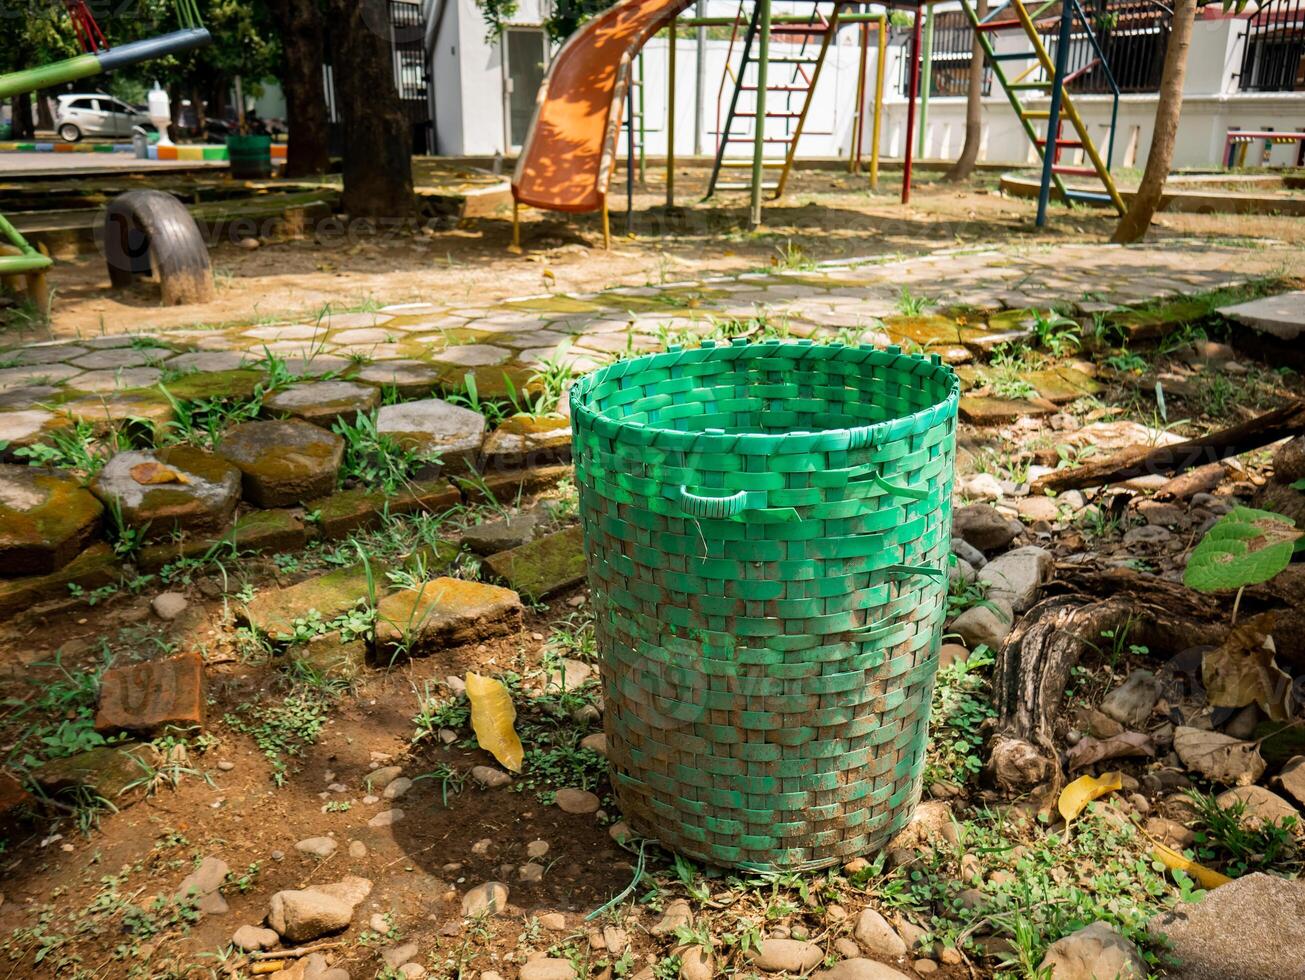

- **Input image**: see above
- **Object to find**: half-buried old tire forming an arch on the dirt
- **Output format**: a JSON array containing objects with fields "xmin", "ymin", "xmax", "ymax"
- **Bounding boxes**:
[{"xmin": 103, "ymin": 191, "xmax": 213, "ymax": 307}]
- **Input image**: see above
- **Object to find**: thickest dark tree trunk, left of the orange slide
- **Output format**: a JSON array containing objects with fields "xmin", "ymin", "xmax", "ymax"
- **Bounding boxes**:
[{"xmin": 330, "ymin": 0, "xmax": 415, "ymax": 222}]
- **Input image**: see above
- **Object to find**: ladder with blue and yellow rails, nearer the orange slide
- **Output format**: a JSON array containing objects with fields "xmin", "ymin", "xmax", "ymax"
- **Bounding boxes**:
[{"xmin": 706, "ymin": 0, "xmax": 843, "ymax": 198}]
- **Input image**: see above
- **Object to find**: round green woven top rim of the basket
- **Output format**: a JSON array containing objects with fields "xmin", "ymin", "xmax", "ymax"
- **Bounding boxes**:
[{"xmin": 569, "ymin": 338, "xmax": 960, "ymax": 453}]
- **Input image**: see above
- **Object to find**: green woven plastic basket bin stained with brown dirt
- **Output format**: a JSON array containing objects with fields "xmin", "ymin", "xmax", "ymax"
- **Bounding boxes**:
[{"xmin": 570, "ymin": 342, "xmax": 959, "ymax": 872}]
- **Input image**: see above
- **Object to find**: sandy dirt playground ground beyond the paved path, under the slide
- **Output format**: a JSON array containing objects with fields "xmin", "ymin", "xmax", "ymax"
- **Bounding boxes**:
[{"xmin": 28, "ymin": 168, "xmax": 1305, "ymax": 347}]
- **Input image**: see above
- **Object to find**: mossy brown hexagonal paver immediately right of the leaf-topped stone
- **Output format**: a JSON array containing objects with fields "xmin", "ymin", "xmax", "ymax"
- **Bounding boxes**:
[{"xmin": 218, "ymin": 419, "xmax": 345, "ymax": 508}]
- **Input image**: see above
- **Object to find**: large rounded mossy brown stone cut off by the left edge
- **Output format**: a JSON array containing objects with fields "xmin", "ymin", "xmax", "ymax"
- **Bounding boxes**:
[{"xmin": 0, "ymin": 463, "xmax": 104, "ymax": 578}]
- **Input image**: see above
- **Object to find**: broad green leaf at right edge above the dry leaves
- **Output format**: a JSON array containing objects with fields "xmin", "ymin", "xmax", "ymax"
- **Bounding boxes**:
[{"xmin": 1182, "ymin": 508, "xmax": 1302, "ymax": 592}]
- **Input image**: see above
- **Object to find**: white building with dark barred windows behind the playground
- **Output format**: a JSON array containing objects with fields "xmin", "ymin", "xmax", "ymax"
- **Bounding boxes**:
[{"xmin": 420, "ymin": 0, "xmax": 1305, "ymax": 167}]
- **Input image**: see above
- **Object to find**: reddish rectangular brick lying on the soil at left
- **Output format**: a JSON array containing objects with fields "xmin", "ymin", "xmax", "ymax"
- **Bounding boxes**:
[{"xmin": 95, "ymin": 652, "xmax": 205, "ymax": 736}]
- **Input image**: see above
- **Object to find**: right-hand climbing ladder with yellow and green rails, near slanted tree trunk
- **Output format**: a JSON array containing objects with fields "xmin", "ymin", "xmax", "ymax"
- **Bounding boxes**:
[{"xmin": 960, "ymin": 0, "xmax": 1125, "ymax": 215}]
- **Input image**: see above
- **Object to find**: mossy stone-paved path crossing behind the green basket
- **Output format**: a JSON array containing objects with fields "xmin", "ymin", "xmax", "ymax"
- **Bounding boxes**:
[{"xmin": 0, "ymin": 244, "xmax": 1274, "ymax": 417}]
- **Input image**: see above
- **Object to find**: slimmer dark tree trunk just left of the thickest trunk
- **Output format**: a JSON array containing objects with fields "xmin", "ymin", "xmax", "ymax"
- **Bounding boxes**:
[{"xmin": 268, "ymin": 0, "xmax": 330, "ymax": 177}]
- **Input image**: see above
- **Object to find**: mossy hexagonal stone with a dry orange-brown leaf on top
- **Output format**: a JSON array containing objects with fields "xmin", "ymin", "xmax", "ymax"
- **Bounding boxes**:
[{"xmin": 90, "ymin": 446, "xmax": 240, "ymax": 535}]
